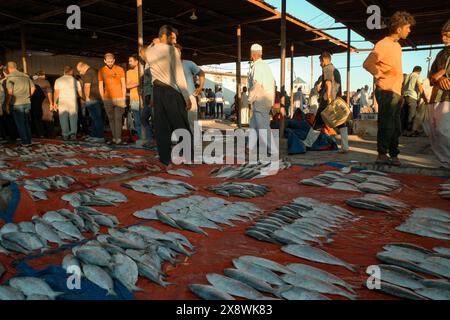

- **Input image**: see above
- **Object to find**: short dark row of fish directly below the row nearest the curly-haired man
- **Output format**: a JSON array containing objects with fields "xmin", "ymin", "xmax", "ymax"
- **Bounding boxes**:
[{"xmin": 345, "ymin": 193, "xmax": 409, "ymax": 212}]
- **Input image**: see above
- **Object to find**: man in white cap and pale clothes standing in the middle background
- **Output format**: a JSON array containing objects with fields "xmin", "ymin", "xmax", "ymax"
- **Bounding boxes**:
[{"xmin": 248, "ymin": 44, "xmax": 275, "ymax": 153}]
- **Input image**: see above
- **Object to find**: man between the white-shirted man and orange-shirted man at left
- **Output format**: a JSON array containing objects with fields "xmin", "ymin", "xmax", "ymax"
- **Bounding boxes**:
[{"xmin": 77, "ymin": 62, "xmax": 105, "ymax": 143}]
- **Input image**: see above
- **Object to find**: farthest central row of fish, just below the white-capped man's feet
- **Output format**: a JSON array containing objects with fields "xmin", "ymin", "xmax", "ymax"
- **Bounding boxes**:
[{"xmin": 210, "ymin": 161, "xmax": 291, "ymax": 179}]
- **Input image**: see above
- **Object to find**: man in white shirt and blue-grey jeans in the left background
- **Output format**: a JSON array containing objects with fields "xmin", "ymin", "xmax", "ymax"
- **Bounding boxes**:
[{"xmin": 54, "ymin": 66, "xmax": 83, "ymax": 140}]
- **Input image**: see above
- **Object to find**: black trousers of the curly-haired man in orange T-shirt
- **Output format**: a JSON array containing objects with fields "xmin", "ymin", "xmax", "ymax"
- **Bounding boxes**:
[{"xmin": 375, "ymin": 89, "xmax": 402, "ymax": 157}]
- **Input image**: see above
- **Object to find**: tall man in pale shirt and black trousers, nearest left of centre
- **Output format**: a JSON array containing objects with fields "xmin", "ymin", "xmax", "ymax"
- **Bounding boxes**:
[{"xmin": 145, "ymin": 25, "xmax": 192, "ymax": 166}]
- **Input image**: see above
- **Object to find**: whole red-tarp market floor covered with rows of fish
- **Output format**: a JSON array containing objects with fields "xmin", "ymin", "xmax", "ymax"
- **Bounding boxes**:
[{"xmin": 0, "ymin": 143, "xmax": 450, "ymax": 300}]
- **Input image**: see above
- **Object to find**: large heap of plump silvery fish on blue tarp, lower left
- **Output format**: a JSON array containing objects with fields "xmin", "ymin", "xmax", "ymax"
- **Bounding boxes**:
[{"xmin": 41, "ymin": 225, "xmax": 195, "ymax": 295}]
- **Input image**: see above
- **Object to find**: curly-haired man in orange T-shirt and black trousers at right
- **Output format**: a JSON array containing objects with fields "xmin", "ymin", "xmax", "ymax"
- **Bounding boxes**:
[{"xmin": 363, "ymin": 11, "xmax": 415, "ymax": 166}]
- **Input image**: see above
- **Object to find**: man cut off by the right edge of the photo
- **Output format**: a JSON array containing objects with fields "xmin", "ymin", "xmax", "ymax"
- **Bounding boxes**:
[{"xmin": 429, "ymin": 19, "xmax": 450, "ymax": 168}]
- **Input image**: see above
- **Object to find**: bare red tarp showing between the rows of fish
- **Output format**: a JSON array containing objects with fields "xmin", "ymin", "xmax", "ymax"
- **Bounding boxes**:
[{"xmin": 0, "ymin": 141, "xmax": 450, "ymax": 299}]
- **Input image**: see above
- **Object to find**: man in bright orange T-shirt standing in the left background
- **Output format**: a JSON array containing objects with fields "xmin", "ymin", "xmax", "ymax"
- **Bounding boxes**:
[{"xmin": 98, "ymin": 53, "xmax": 127, "ymax": 144}]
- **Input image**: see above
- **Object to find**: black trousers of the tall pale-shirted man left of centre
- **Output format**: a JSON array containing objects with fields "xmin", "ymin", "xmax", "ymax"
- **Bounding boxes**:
[{"xmin": 153, "ymin": 82, "xmax": 192, "ymax": 165}]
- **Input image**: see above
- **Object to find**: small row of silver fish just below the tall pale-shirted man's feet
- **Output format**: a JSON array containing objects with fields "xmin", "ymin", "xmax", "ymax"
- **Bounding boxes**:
[{"xmin": 122, "ymin": 176, "xmax": 197, "ymax": 198}]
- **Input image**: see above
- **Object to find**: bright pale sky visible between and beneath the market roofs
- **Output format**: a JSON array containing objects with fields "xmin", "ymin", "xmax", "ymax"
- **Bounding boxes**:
[{"xmin": 202, "ymin": 0, "xmax": 439, "ymax": 91}]
